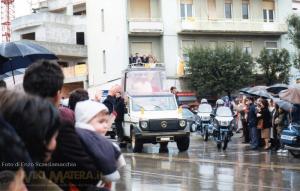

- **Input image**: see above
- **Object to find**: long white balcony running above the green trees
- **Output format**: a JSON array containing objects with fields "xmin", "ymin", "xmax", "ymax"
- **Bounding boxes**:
[{"xmin": 178, "ymin": 17, "xmax": 288, "ymax": 35}]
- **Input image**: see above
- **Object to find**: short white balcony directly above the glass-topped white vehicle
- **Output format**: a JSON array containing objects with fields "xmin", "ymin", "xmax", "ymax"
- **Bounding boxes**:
[{"xmin": 128, "ymin": 18, "xmax": 164, "ymax": 36}]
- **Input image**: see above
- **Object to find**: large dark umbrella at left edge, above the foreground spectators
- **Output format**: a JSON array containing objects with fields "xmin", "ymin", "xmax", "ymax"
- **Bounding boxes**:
[{"xmin": 0, "ymin": 41, "xmax": 57, "ymax": 83}]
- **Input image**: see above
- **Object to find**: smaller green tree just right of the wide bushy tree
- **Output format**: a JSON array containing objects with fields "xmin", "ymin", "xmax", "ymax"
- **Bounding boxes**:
[{"xmin": 257, "ymin": 49, "xmax": 291, "ymax": 85}]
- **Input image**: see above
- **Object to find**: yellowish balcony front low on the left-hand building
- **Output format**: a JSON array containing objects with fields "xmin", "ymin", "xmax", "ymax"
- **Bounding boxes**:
[{"xmin": 62, "ymin": 64, "xmax": 87, "ymax": 83}]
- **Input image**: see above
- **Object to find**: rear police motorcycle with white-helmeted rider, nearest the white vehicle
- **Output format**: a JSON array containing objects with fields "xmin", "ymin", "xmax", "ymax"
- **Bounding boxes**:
[{"xmin": 197, "ymin": 99, "xmax": 213, "ymax": 141}]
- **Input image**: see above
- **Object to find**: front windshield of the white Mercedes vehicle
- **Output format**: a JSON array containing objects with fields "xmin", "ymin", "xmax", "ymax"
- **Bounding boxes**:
[{"xmin": 132, "ymin": 95, "xmax": 177, "ymax": 111}]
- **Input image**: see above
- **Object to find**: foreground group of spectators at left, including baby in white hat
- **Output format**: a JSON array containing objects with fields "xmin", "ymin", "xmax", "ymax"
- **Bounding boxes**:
[{"xmin": 0, "ymin": 61, "xmax": 126, "ymax": 191}]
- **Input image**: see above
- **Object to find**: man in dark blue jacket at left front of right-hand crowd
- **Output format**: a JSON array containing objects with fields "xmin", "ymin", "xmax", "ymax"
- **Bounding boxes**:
[{"xmin": 248, "ymin": 97, "xmax": 259, "ymax": 150}]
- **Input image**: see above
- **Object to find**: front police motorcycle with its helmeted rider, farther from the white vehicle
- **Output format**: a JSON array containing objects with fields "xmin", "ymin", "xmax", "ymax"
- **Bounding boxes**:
[{"xmin": 211, "ymin": 100, "xmax": 235, "ymax": 150}]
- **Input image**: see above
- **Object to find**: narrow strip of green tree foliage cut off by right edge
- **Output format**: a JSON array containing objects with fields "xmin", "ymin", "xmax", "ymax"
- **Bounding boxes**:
[{"xmin": 288, "ymin": 14, "xmax": 300, "ymax": 70}]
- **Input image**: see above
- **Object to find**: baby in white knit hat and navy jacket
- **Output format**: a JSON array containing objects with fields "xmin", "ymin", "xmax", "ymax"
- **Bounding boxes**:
[{"xmin": 75, "ymin": 100, "xmax": 124, "ymax": 188}]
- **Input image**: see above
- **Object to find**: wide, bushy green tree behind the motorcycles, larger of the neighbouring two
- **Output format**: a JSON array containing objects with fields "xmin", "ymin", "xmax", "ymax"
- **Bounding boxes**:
[{"xmin": 187, "ymin": 47, "xmax": 253, "ymax": 96}]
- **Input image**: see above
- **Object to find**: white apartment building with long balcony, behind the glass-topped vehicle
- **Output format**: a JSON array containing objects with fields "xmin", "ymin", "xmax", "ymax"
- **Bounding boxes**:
[{"xmin": 86, "ymin": 0, "xmax": 292, "ymax": 88}]
